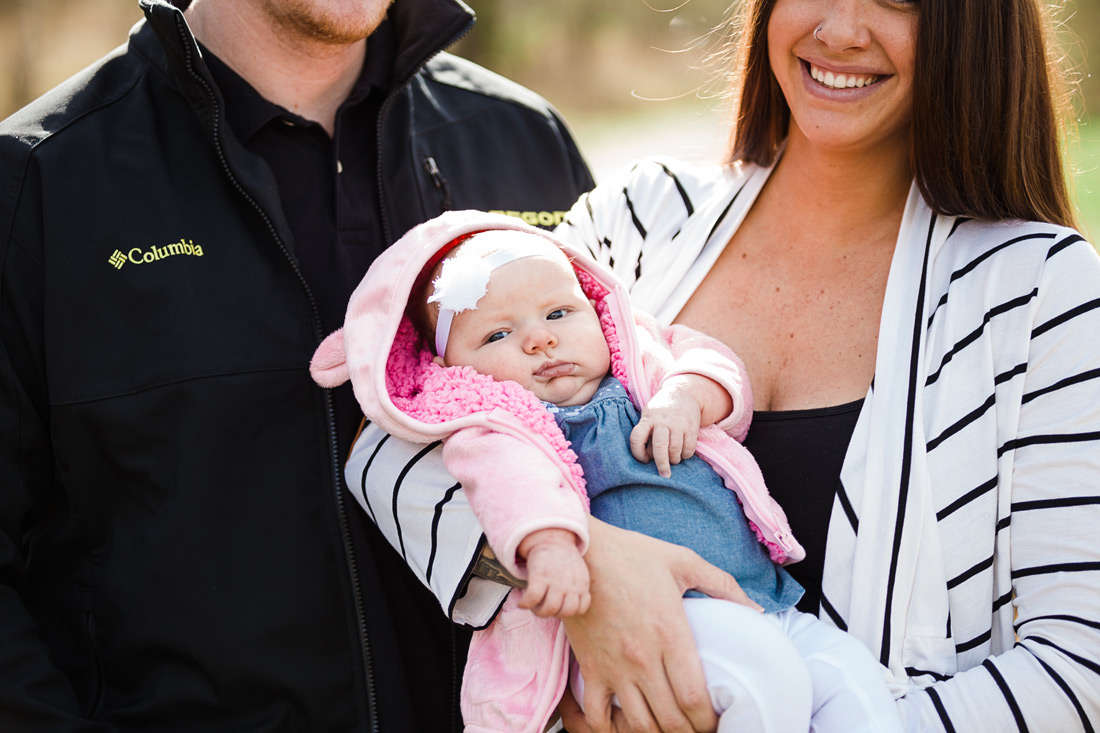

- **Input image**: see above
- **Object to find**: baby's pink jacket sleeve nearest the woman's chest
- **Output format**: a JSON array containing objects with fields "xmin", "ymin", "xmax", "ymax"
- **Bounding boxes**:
[{"xmin": 635, "ymin": 314, "xmax": 752, "ymax": 440}]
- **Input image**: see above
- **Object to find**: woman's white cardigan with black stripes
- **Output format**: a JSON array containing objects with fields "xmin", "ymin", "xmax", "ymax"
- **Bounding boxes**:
[{"xmin": 348, "ymin": 160, "xmax": 1100, "ymax": 733}]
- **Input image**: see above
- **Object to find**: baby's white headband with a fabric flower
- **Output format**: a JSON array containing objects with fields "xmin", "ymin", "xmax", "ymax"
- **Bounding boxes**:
[{"xmin": 428, "ymin": 243, "xmax": 558, "ymax": 357}]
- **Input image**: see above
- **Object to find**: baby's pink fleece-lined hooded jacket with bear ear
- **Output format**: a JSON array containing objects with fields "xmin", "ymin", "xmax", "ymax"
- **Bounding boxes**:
[{"xmin": 310, "ymin": 211, "xmax": 804, "ymax": 733}]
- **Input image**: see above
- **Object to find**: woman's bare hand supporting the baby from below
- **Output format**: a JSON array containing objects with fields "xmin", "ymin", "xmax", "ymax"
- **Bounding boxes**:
[{"xmin": 561, "ymin": 518, "xmax": 759, "ymax": 733}]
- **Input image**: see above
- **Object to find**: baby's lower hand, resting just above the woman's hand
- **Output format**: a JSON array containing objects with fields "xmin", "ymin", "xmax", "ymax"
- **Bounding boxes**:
[{"xmin": 519, "ymin": 529, "xmax": 592, "ymax": 619}]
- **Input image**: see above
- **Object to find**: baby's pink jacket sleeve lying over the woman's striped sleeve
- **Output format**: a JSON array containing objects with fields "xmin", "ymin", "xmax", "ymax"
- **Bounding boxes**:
[{"xmin": 443, "ymin": 427, "xmax": 589, "ymax": 578}]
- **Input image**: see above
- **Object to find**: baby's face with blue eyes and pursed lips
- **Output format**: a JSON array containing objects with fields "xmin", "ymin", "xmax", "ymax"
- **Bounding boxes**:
[{"xmin": 436, "ymin": 256, "xmax": 611, "ymax": 406}]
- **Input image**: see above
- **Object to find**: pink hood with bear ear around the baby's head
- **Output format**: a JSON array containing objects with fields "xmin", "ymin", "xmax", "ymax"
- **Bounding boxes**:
[{"xmin": 309, "ymin": 211, "xmax": 633, "ymax": 442}]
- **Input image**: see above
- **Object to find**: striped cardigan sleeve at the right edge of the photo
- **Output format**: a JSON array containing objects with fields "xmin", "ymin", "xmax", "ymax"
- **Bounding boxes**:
[{"xmin": 900, "ymin": 233, "xmax": 1100, "ymax": 733}]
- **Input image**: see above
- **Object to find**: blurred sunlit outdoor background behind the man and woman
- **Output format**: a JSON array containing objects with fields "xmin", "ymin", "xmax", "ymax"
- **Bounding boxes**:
[{"xmin": 0, "ymin": 0, "xmax": 1100, "ymax": 236}]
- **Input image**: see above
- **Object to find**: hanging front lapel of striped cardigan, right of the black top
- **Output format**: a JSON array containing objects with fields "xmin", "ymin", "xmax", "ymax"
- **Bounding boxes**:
[{"xmin": 822, "ymin": 183, "xmax": 954, "ymax": 694}]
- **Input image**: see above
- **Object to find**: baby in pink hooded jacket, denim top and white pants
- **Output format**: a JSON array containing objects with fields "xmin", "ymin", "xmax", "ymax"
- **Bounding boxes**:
[{"xmin": 311, "ymin": 212, "xmax": 900, "ymax": 733}]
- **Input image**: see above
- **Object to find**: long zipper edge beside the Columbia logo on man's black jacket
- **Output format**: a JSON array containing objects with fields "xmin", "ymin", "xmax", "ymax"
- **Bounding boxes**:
[{"xmin": 175, "ymin": 13, "xmax": 381, "ymax": 733}]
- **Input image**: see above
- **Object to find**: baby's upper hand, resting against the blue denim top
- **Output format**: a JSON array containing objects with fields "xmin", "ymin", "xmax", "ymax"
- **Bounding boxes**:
[{"xmin": 630, "ymin": 375, "xmax": 703, "ymax": 479}]
